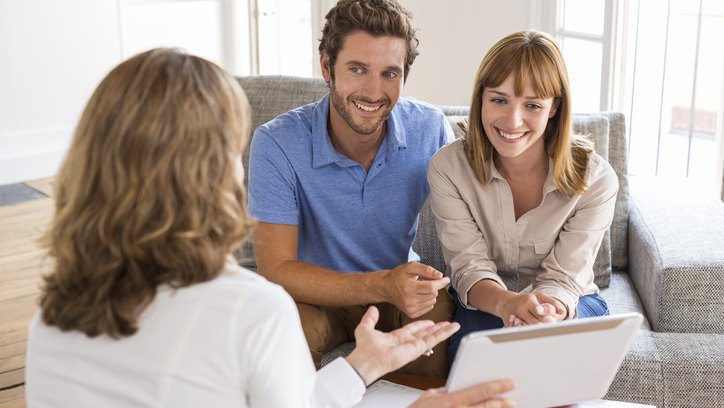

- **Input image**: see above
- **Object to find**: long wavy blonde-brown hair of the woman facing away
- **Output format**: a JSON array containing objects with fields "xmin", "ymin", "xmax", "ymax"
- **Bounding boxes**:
[{"xmin": 40, "ymin": 49, "xmax": 251, "ymax": 338}]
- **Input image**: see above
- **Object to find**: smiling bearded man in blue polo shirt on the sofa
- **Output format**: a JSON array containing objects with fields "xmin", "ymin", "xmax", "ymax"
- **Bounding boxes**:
[{"xmin": 249, "ymin": 0, "xmax": 453, "ymax": 377}]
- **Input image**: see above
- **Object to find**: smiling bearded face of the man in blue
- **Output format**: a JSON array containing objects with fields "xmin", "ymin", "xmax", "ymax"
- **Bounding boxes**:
[{"xmin": 321, "ymin": 31, "xmax": 406, "ymax": 137}]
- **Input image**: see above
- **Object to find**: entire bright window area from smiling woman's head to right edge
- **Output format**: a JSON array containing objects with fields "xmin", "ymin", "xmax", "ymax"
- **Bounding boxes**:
[{"xmin": 544, "ymin": 0, "xmax": 724, "ymax": 196}]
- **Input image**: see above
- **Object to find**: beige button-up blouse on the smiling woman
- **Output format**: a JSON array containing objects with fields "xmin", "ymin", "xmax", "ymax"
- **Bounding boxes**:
[{"xmin": 427, "ymin": 139, "xmax": 618, "ymax": 318}]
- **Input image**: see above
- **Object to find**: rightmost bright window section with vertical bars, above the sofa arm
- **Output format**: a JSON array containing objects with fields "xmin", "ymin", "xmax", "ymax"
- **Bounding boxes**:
[{"xmin": 620, "ymin": 0, "xmax": 724, "ymax": 191}]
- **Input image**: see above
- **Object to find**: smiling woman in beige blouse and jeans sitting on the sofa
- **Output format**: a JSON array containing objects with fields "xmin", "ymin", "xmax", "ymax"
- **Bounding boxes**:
[{"xmin": 428, "ymin": 31, "xmax": 618, "ymax": 361}]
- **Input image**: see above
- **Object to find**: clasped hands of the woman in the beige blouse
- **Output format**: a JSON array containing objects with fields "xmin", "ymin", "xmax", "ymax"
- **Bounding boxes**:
[{"xmin": 500, "ymin": 292, "xmax": 568, "ymax": 327}]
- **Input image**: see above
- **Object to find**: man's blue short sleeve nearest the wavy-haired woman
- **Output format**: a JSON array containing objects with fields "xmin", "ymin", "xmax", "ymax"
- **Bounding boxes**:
[{"xmin": 249, "ymin": 126, "xmax": 299, "ymax": 225}]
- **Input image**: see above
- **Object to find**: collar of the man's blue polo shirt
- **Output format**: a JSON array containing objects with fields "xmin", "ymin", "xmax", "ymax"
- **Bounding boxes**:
[{"xmin": 311, "ymin": 94, "xmax": 407, "ymax": 169}]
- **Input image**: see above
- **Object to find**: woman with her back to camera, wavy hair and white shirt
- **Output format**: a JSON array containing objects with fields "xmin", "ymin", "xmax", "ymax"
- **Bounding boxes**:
[{"xmin": 26, "ymin": 49, "xmax": 511, "ymax": 408}]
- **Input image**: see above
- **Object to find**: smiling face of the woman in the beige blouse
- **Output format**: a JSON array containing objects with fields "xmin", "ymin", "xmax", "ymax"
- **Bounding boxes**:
[{"xmin": 481, "ymin": 74, "xmax": 558, "ymax": 159}]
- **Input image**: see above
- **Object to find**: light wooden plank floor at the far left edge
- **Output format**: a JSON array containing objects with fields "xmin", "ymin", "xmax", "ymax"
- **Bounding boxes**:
[{"xmin": 0, "ymin": 180, "xmax": 53, "ymax": 408}]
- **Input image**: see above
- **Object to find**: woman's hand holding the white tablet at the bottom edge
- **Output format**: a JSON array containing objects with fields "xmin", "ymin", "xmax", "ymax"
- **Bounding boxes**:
[{"xmin": 410, "ymin": 380, "xmax": 515, "ymax": 408}]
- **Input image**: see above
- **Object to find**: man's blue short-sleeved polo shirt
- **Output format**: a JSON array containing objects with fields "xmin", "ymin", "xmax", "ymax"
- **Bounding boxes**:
[{"xmin": 249, "ymin": 95, "xmax": 453, "ymax": 272}]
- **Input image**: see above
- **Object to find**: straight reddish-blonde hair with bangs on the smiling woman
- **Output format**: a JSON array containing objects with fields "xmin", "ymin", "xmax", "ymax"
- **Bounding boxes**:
[{"xmin": 464, "ymin": 30, "xmax": 593, "ymax": 197}]
